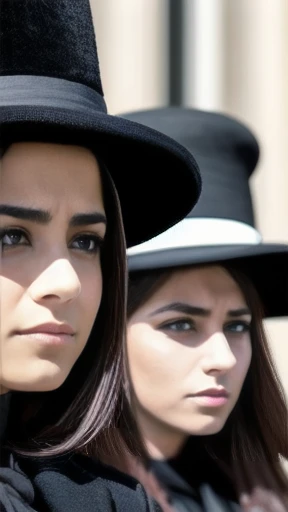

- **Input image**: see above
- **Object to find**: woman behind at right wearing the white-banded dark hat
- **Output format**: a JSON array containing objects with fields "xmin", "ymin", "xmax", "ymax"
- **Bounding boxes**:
[{"xmin": 117, "ymin": 108, "xmax": 288, "ymax": 512}]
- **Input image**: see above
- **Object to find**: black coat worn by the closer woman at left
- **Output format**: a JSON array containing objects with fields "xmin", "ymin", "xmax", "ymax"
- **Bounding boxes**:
[{"xmin": 0, "ymin": 395, "xmax": 160, "ymax": 512}]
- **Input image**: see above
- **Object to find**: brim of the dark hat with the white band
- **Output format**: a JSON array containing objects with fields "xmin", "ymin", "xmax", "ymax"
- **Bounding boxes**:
[{"xmin": 128, "ymin": 243, "xmax": 288, "ymax": 317}]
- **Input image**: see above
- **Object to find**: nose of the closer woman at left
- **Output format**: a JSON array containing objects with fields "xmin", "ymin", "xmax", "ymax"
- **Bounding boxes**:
[{"xmin": 29, "ymin": 258, "xmax": 81, "ymax": 303}]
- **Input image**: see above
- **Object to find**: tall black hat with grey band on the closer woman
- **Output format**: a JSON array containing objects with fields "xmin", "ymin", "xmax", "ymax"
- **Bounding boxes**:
[{"xmin": 0, "ymin": 0, "xmax": 201, "ymax": 246}]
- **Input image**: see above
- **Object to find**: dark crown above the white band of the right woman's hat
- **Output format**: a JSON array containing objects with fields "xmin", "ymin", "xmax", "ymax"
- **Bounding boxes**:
[{"xmin": 122, "ymin": 107, "xmax": 259, "ymax": 226}]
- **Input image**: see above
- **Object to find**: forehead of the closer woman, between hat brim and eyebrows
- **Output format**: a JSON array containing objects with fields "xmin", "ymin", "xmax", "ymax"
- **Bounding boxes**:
[{"xmin": 1, "ymin": 143, "xmax": 102, "ymax": 210}]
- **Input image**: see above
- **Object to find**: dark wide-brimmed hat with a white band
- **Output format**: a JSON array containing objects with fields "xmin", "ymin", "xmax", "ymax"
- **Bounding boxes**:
[{"xmin": 125, "ymin": 107, "xmax": 288, "ymax": 317}]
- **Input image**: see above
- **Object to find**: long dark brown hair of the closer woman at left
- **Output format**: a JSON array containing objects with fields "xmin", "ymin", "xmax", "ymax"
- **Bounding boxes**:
[{"xmin": 2, "ymin": 142, "xmax": 143, "ymax": 459}]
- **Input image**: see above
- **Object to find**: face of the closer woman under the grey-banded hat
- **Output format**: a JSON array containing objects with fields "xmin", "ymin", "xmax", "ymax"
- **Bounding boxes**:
[{"xmin": 0, "ymin": 142, "xmax": 106, "ymax": 392}]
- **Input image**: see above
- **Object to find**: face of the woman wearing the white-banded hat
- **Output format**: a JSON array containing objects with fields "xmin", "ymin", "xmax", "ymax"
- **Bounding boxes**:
[{"xmin": 128, "ymin": 266, "xmax": 251, "ymax": 458}]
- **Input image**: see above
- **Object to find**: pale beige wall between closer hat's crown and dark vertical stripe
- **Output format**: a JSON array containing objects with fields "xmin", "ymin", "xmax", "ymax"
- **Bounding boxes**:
[{"xmin": 90, "ymin": 0, "xmax": 168, "ymax": 114}]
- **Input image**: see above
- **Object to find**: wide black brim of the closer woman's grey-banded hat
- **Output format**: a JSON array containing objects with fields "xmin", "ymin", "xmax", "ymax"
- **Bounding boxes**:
[{"xmin": 0, "ymin": 104, "xmax": 201, "ymax": 247}]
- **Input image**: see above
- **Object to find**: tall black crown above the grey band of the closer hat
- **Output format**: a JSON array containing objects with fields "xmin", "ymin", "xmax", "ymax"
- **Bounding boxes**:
[{"xmin": 0, "ymin": 0, "xmax": 103, "ymax": 96}]
